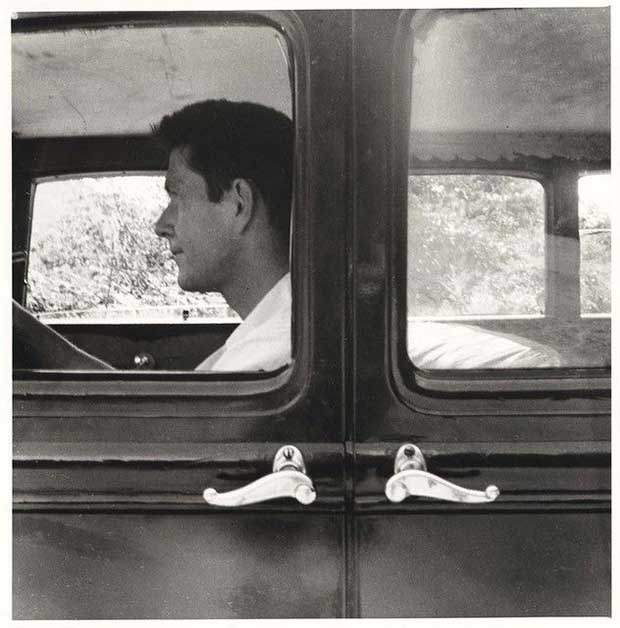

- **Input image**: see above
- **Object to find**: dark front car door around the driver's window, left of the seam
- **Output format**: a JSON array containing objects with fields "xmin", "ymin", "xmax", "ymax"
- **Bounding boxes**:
[{"xmin": 13, "ymin": 13, "xmax": 350, "ymax": 619}]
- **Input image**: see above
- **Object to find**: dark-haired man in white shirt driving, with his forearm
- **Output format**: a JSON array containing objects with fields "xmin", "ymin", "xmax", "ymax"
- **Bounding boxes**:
[{"xmin": 14, "ymin": 100, "xmax": 293, "ymax": 371}]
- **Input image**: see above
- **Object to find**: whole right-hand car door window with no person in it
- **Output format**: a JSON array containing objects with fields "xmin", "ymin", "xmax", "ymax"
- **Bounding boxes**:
[{"xmin": 407, "ymin": 8, "xmax": 611, "ymax": 370}]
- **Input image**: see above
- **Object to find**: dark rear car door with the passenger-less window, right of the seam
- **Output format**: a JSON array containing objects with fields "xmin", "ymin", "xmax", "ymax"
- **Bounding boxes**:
[{"xmin": 349, "ymin": 9, "xmax": 610, "ymax": 617}]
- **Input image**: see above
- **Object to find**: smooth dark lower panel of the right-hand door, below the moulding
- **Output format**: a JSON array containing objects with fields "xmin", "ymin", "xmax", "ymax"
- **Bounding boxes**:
[{"xmin": 356, "ymin": 505, "xmax": 611, "ymax": 617}]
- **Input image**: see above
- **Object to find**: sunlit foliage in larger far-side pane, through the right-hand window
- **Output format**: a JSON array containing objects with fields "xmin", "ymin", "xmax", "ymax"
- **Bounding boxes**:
[{"xmin": 407, "ymin": 174, "xmax": 545, "ymax": 317}]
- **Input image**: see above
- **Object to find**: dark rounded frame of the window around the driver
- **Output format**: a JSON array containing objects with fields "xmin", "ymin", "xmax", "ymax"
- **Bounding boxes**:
[{"xmin": 12, "ymin": 11, "xmax": 313, "ymax": 416}]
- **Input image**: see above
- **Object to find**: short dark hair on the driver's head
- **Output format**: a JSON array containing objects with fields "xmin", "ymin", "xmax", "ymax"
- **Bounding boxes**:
[{"xmin": 153, "ymin": 100, "xmax": 293, "ymax": 243}]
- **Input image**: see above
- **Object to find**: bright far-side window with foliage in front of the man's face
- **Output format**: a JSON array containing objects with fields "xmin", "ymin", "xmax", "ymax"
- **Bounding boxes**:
[{"xmin": 27, "ymin": 175, "xmax": 239, "ymax": 323}]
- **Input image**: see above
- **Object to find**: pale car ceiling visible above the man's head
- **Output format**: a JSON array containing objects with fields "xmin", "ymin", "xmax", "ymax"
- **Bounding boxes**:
[{"xmin": 11, "ymin": 24, "xmax": 292, "ymax": 137}]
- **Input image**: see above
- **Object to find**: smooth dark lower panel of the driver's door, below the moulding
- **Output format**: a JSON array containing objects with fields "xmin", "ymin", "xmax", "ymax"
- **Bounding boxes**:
[{"xmin": 13, "ymin": 511, "xmax": 345, "ymax": 619}]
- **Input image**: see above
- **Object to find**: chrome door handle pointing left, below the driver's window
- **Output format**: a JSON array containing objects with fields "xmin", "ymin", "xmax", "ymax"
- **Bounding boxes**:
[{"xmin": 202, "ymin": 445, "xmax": 316, "ymax": 507}]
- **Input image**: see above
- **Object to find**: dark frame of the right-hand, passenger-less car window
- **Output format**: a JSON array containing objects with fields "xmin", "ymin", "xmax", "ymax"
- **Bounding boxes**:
[{"xmin": 385, "ymin": 11, "xmax": 611, "ymax": 416}]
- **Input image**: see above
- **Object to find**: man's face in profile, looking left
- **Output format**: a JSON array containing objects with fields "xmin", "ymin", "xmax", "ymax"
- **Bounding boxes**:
[{"xmin": 155, "ymin": 147, "xmax": 235, "ymax": 292}]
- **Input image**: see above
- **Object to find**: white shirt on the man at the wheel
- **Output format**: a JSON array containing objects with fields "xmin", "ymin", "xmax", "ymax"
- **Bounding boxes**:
[{"xmin": 196, "ymin": 273, "xmax": 292, "ymax": 371}]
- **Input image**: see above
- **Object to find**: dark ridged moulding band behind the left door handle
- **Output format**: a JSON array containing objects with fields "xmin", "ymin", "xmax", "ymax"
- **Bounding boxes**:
[{"xmin": 13, "ymin": 444, "xmax": 344, "ymax": 513}]
